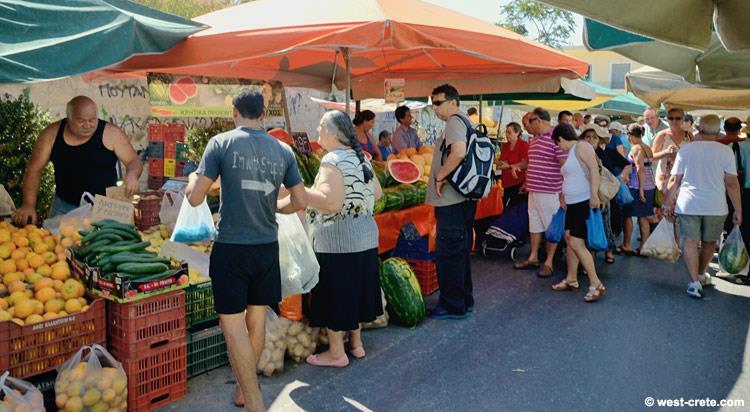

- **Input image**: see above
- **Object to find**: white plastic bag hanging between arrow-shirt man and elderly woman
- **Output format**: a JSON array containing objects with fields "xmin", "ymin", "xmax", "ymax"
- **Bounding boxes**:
[{"xmin": 276, "ymin": 213, "xmax": 320, "ymax": 298}]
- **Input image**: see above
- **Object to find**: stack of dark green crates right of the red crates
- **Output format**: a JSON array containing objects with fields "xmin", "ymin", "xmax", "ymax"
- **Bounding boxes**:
[{"xmin": 185, "ymin": 282, "xmax": 229, "ymax": 378}]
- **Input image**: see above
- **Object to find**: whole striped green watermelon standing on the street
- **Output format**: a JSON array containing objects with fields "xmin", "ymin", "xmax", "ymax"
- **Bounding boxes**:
[{"xmin": 380, "ymin": 258, "xmax": 427, "ymax": 327}]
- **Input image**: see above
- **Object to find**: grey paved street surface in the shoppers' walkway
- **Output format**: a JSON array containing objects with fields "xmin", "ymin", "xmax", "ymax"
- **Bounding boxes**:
[{"xmin": 166, "ymin": 248, "xmax": 750, "ymax": 412}]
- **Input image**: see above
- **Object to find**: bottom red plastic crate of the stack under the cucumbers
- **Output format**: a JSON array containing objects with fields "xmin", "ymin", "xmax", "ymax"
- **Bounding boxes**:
[{"xmin": 122, "ymin": 337, "xmax": 187, "ymax": 412}]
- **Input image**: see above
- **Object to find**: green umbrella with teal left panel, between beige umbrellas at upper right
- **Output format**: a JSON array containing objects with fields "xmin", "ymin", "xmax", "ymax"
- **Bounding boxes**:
[{"xmin": 584, "ymin": 19, "xmax": 750, "ymax": 89}]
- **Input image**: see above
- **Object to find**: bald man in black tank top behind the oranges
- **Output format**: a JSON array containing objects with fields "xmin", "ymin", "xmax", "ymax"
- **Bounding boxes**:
[{"xmin": 13, "ymin": 96, "xmax": 143, "ymax": 225}]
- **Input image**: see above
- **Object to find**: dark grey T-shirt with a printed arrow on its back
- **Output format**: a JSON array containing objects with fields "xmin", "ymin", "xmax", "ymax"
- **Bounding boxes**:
[{"xmin": 196, "ymin": 127, "xmax": 302, "ymax": 245}]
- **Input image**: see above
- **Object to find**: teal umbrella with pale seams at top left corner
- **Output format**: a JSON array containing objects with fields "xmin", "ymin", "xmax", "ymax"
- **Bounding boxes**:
[{"xmin": 0, "ymin": 0, "xmax": 206, "ymax": 83}]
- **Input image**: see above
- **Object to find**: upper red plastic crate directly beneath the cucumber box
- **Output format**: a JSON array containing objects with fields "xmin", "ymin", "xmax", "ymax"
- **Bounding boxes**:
[{"xmin": 107, "ymin": 290, "xmax": 185, "ymax": 361}]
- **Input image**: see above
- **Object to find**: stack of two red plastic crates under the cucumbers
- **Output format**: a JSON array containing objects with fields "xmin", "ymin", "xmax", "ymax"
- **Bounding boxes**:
[{"xmin": 107, "ymin": 290, "xmax": 187, "ymax": 411}]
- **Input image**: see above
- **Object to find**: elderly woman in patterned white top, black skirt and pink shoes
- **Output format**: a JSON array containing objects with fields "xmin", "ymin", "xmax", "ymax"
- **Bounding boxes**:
[{"xmin": 307, "ymin": 110, "xmax": 383, "ymax": 368}]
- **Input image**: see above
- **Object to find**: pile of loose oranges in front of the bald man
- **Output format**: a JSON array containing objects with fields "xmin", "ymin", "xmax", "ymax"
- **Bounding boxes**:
[{"xmin": 0, "ymin": 221, "xmax": 88, "ymax": 325}]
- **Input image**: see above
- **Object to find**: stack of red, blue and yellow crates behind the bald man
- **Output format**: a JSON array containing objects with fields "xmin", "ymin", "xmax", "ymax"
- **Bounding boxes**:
[{"xmin": 148, "ymin": 123, "xmax": 188, "ymax": 190}]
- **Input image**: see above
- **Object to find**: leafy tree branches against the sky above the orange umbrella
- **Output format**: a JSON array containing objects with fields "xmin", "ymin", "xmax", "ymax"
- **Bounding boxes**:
[{"xmin": 498, "ymin": 0, "xmax": 575, "ymax": 49}]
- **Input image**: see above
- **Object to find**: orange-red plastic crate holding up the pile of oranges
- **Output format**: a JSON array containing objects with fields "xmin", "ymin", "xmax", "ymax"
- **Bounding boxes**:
[{"xmin": 0, "ymin": 299, "xmax": 107, "ymax": 379}]
